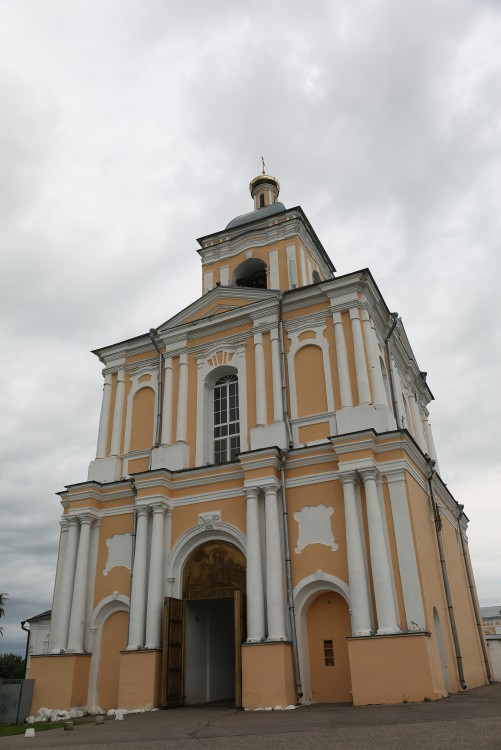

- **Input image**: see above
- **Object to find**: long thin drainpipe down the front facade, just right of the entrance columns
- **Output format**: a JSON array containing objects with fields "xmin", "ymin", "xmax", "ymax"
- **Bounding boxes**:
[{"xmin": 278, "ymin": 292, "xmax": 303, "ymax": 699}]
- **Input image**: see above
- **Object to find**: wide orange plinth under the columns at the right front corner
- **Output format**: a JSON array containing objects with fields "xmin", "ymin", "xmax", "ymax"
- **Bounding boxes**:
[{"xmin": 348, "ymin": 633, "xmax": 436, "ymax": 706}]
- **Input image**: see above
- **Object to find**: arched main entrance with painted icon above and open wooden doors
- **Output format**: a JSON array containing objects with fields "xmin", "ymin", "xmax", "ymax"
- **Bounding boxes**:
[{"xmin": 162, "ymin": 541, "xmax": 246, "ymax": 707}]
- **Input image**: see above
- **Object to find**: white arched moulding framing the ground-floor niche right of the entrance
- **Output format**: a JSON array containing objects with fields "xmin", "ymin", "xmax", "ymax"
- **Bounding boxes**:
[{"xmin": 293, "ymin": 570, "xmax": 351, "ymax": 703}]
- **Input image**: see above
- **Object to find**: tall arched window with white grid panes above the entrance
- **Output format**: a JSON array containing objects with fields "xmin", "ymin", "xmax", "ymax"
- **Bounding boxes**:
[{"xmin": 214, "ymin": 375, "xmax": 240, "ymax": 464}]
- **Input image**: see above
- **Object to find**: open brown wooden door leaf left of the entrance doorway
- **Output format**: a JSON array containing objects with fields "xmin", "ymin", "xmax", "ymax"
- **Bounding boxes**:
[{"xmin": 161, "ymin": 596, "xmax": 186, "ymax": 708}]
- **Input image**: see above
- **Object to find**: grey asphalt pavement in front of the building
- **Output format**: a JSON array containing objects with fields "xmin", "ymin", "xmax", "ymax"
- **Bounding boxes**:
[{"xmin": 0, "ymin": 683, "xmax": 501, "ymax": 750}]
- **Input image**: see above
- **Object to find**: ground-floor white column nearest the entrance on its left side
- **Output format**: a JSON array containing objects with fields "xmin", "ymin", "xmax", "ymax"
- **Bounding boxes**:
[{"xmin": 146, "ymin": 503, "xmax": 165, "ymax": 648}]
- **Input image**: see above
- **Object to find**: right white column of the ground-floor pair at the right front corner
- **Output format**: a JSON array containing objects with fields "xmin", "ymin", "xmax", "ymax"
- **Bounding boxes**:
[{"xmin": 359, "ymin": 468, "xmax": 399, "ymax": 633}]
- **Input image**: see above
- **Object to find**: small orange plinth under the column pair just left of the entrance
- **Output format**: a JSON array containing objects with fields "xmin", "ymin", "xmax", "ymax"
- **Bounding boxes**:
[{"xmin": 118, "ymin": 650, "xmax": 162, "ymax": 709}]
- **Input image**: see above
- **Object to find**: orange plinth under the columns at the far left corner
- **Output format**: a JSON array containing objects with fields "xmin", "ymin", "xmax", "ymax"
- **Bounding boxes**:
[{"xmin": 30, "ymin": 654, "xmax": 91, "ymax": 714}]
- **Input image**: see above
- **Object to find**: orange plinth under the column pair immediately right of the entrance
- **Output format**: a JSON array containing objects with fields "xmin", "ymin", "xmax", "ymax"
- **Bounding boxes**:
[{"xmin": 242, "ymin": 642, "xmax": 297, "ymax": 708}]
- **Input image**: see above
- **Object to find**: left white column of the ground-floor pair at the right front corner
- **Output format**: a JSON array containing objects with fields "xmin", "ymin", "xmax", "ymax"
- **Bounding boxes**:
[{"xmin": 339, "ymin": 471, "xmax": 371, "ymax": 635}]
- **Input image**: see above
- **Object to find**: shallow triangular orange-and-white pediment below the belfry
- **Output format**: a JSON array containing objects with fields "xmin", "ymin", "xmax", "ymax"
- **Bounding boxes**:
[{"xmin": 158, "ymin": 286, "xmax": 276, "ymax": 333}]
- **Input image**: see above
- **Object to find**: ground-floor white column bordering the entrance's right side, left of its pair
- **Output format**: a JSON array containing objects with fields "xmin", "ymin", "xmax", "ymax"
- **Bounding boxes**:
[{"xmin": 245, "ymin": 487, "xmax": 265, "ymax": 643}]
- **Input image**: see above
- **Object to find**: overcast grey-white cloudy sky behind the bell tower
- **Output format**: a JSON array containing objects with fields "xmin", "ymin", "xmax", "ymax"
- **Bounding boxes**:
[{"xmin": 0, "ymin": 0, "xmax": 501, "ymax": 652}]
